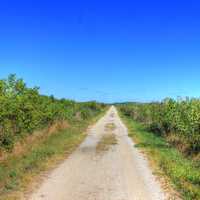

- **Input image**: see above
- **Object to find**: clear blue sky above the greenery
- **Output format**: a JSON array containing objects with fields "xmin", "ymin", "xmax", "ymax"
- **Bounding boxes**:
[{"xmin": 0, "ymin": 0, "xmax": 200, "ymax": 102}]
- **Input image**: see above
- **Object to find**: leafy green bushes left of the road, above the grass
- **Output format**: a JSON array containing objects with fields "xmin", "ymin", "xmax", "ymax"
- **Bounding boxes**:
[{"xmin": 0, "ymin": 75, "xmax": 105, "ymax": 150}]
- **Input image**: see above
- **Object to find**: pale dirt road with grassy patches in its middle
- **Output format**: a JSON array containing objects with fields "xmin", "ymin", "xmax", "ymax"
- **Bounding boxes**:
[{"xmin": 28, "ymin": 107, "xmax": 165, "ymax": 200}]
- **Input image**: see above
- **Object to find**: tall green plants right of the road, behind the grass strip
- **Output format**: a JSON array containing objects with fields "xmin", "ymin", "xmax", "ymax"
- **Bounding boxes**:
[{"xmin": 119, "ymin": 98, "xmax": 200, "ymax": 155}]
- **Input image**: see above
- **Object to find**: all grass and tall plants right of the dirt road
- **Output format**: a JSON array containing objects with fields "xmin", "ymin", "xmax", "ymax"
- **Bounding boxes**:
[{"xmin": 118, "ymin": 99, "xmax": 200, "ymax": 200}]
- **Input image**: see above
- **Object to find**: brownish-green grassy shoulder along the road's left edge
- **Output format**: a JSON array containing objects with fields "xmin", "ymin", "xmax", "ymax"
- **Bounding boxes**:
[{"xmin": 0, "ymin": 111, "xmax": 105, "ymax": 200}]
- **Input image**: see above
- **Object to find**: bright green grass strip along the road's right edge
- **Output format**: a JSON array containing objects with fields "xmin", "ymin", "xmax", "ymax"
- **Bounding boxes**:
[{"xmin": 120, "ymin": 113, "xmax": 200, "ymax": 200}]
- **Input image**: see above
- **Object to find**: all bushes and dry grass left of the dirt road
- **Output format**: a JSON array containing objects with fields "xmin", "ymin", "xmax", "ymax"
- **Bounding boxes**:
[{"xmin": 0, "ymin": 75, "xmax": 106, "ymax": 199}]
